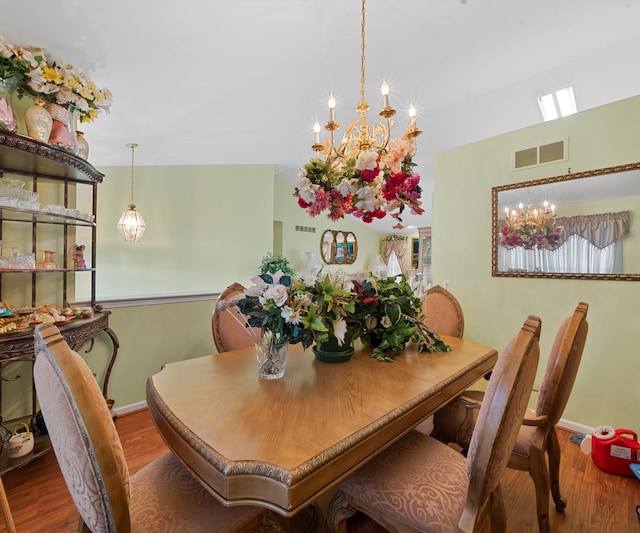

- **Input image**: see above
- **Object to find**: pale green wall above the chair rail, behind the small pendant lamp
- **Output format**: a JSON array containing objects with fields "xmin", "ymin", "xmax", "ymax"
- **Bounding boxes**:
[{"xmin": 97, "ymin": 165, "xmax": 274, "ymax": 298}]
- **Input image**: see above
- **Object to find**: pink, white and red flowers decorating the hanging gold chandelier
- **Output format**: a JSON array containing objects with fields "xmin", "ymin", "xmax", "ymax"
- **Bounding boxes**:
[{"xmin": 294, "ymin": 138, "xmax": 424, "ymax": 228}]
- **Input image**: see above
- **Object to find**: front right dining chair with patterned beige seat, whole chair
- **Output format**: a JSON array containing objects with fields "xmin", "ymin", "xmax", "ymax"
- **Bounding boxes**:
[{"xmin": 326, "ymin": 316, "xmax": 541, "ymax": 533}]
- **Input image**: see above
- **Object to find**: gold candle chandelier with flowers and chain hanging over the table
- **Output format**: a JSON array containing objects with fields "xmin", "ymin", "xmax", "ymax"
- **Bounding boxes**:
[{"xmin": 294, "ymin": 0, "xmax": 424, "ymax": 229}]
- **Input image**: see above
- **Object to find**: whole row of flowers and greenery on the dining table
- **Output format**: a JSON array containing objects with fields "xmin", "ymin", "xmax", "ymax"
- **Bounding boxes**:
[{"xmin": 217, "ymin": 256, "xmax": 451, "ymax": 368}]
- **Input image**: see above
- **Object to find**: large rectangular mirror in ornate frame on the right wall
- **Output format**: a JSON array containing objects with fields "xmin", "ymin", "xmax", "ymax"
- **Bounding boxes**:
[{"xmin": 492, "ymin": 163, "xmax": 640, "ymax": 280}]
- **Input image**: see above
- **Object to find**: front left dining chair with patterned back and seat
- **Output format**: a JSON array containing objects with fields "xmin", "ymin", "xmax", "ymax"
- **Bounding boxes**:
[{"xmin": 33, "ymin": 324, "xmax": 264, "ymax": 533}]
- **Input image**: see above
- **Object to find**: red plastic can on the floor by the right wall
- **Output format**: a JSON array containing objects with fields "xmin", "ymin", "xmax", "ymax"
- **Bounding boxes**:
[{"xmin": 591, "ymin": 428, "xmax": 640, "ymax": 477}]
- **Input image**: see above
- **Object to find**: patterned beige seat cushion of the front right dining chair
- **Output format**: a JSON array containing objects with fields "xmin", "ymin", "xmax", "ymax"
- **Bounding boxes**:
[{"xmin": 340, "ymin": 431, "xmax": 469, "ymax": 533}]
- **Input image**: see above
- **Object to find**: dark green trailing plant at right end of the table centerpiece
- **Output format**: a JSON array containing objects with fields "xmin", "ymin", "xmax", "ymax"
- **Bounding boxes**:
[{"xmin": 353, "ymin": 276, "xmax": 451, "ymax": 361}]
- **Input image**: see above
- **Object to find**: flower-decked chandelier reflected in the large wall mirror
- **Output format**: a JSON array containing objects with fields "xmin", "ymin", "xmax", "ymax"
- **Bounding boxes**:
[{"xmin": 500, "ymin": 200, "xmax": 563, "ymax": 250}]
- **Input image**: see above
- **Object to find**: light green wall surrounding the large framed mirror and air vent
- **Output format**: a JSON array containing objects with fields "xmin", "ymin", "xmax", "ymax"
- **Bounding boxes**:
[{"xmin": 433, "ymin": 93, "xmax": 640, "ymax": 431}]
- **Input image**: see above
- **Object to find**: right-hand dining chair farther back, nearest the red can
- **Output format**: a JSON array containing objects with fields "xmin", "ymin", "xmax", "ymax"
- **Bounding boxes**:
[{"xmin": 432, "ymin": 302, "xmax": 589, "ymax": 533}]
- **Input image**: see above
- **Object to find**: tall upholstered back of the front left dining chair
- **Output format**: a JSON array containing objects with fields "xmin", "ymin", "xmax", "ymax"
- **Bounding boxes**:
[{"xmin": 33, "ymin": 324, "xmax": 130, "ymax": 533}]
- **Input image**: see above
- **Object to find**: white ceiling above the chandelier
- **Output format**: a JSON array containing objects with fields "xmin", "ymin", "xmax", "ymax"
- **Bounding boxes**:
[{"xmin": 0, "ymin": 0, "xmax": 640, "ymax": 232}]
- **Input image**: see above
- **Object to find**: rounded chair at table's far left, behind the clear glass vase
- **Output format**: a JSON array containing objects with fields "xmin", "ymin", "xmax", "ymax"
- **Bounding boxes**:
[{"xmin": 211, "ymin": 283, "xmax": 260, "ymax": 353}]
